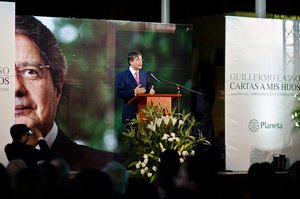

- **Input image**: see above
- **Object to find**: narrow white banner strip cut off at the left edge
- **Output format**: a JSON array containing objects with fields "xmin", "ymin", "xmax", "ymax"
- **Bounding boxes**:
[{"xmin": 0, "ymin": 2, "xmax": 15, "ymax": 166}]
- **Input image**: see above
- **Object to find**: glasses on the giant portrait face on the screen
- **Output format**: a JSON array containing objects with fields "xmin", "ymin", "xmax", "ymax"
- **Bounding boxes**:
[{"xmin": 16, "ymin": 65, "xmax": 50, "ymax": 80}]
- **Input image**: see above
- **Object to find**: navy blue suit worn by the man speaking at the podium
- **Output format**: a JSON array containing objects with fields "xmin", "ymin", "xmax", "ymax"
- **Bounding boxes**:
[{"xmin": 116, "ymin": 68, "xmax": 150, "ymax": 124}]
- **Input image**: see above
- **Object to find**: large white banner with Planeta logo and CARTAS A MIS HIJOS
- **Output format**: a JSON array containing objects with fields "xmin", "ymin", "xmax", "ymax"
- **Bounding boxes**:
[{"xmin": 225, "ymin": 16, "xmax": 300, "ymax": 171}]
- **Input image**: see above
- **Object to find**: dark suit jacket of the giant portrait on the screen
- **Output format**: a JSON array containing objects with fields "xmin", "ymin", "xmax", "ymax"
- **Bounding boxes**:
[{"xmin": 50, "ymin": 129, "xmax": 122, "ymax": 171}]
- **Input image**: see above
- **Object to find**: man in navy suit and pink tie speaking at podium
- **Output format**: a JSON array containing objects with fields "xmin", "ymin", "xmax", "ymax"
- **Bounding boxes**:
[{"xmin": 116, "ymin": 51, "xmax": 155, "ymax": 128}]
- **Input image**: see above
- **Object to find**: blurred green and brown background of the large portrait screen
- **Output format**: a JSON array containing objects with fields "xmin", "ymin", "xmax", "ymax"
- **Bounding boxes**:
[{"xmin": 39, "ymin": 17, "xmax": 192, "ymax": 151}]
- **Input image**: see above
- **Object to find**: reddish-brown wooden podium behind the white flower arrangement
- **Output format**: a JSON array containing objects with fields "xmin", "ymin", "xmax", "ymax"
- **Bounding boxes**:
[{"xmin": 128, "ymin": 94, "xmax": 182, "ymax": 121}]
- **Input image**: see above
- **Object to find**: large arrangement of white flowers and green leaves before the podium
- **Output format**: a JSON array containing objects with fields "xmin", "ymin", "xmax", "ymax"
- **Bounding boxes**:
[{"xmin": 123, "ymin": 103, "xmax": 210, "ymax": 182}]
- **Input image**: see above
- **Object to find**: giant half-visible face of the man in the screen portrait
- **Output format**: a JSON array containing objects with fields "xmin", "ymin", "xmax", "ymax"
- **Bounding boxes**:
[{"xmin": 15, "ymin": 33, "xmax": 61, "ymax": 136}]
